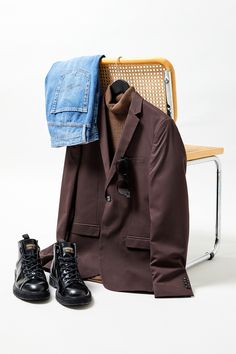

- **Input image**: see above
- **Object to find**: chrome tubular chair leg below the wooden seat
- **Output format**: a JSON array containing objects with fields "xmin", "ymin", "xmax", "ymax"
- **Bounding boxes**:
[{"xmin": 186, "ymin": 156, "xmax": 221, "ymax": 268}]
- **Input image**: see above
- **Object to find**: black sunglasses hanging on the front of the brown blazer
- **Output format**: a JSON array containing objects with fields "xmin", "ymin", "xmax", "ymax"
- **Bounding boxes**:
[{"xmin": 116, "ymin": 157, "xmax": 130, "ymax": 198}]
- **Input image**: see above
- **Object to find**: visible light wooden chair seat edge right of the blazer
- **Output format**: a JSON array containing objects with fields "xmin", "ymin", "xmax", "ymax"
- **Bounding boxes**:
[{"xmin": 184, "ymin": 145, "xmax": 224, "ymax": 161}]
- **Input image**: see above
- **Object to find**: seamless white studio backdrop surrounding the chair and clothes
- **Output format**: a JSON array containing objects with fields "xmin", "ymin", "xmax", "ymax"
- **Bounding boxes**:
[{"xmin": 0, "ymin": 0, "xmax": 236, "ymax": 354}]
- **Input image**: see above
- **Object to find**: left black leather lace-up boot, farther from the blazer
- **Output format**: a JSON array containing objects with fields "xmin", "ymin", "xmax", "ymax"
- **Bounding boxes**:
[{"xmin": 13, "ymin": 234, "xmax": 50, "ymax": 301}]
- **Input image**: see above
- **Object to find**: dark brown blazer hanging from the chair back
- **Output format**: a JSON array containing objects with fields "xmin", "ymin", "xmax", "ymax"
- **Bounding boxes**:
[{"xmin": 41, "ymin": 87, "xmax": 193, "ymax": 297}]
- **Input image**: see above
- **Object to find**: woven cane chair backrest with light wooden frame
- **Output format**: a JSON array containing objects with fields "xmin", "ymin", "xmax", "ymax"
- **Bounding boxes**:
[{"xmin": 100, "ymin": 57, "xmax": 177, "ymax": 120}]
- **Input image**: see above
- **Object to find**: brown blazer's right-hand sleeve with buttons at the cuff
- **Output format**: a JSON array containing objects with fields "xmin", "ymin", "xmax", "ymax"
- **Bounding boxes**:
[{"xmin": 149, "ymin": 117, "xmax": 193, "ymax": 298}]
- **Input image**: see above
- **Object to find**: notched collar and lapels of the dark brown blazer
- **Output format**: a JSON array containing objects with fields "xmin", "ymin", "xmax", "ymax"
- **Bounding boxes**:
[{"xmin": 99, "ymin": 85, "xmax": 143, "ymax": 189}]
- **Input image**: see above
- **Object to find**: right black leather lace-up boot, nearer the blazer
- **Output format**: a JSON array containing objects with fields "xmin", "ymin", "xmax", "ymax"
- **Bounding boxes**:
[{"xmin": 49, "ymin": 241, "xmax": 91, "ymax": 306}]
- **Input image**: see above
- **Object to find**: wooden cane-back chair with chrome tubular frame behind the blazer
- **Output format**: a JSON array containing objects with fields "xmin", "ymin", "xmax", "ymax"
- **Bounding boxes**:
[{"xmin": 100, "ymin": 57, "xmax": 224, "ymax": 268}]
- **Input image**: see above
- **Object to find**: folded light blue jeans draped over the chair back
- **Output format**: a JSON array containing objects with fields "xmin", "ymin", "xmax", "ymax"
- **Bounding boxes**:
[{"xmin": 45, "ymin": 55, "xmax": 104, "ymax": 147}]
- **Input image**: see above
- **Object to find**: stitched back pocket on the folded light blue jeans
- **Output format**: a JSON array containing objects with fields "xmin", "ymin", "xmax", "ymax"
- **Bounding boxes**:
[{"xmin": 50, "ymin": 69, "xmax": 90, "ymax": 114}]
